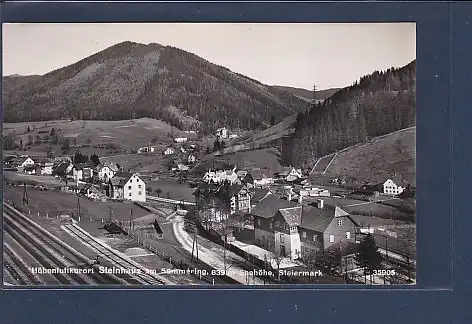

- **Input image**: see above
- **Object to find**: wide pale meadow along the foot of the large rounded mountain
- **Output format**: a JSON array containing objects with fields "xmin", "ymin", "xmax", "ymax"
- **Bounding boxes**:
[{"xmin": 3, "ymin": 118, "xmax": 196, "ymax": 156}]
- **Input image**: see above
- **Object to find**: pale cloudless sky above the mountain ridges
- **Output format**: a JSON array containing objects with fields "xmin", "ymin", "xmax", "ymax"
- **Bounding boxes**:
[{"xmin": 2, "ymin": 23, "xmax": 416, "ymax": 90}]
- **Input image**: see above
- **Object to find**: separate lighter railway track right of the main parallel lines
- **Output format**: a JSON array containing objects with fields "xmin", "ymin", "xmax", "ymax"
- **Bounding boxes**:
[{"xmin": 63, "ymin": 224, "xmax": 172, "ymax": 285}]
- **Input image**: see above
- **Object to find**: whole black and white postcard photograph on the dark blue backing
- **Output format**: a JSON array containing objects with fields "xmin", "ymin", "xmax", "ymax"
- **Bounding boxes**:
[{"xmin": 2, "ymin": 23, "xmax": 416, "ymax": 289}]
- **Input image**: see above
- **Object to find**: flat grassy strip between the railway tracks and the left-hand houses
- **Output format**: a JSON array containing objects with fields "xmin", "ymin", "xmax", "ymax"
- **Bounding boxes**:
[{"xmin": 3, "ymin": 187, "xmax": 148, "ymax": 220}]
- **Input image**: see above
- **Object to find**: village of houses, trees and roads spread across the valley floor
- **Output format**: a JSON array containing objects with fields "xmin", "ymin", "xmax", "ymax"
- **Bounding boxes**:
[{"xmin": 3, "ymin": 127, "xmax": 416, "ymax": 284}]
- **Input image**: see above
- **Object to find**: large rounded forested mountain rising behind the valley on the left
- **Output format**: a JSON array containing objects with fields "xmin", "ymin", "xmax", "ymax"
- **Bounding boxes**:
[{"xmin": 3, "ymin": 42, "xmax": 309, "ymax": 132}]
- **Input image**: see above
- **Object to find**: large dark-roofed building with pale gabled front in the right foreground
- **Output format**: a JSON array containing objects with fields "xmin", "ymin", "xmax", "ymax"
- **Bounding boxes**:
[{"xmin": 250, "ymin": 195, "xmax": 357, "ymax": 259}]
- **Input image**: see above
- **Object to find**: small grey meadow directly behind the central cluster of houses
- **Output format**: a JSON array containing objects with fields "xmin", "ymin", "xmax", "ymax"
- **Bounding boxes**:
[{"xmin": 192, "ymin": 148, "xmax": 282, "ymax": 175}]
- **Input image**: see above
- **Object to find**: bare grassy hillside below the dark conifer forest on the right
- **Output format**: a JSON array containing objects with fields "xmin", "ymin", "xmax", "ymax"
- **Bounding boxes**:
[{"xmin": 314, "ymin": 127, "xmax": 416, "ymax": 186}]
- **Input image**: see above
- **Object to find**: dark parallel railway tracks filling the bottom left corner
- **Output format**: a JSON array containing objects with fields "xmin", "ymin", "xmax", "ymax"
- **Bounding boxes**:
[{"xmin": 3, "ymin": 204, "xmax": 123, "ymax": 285}]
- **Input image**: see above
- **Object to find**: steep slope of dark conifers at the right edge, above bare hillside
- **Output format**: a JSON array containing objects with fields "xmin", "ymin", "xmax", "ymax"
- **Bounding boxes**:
[{"xmin": 282, "ymin": 60, "xmax": 416, "ymax": 167}]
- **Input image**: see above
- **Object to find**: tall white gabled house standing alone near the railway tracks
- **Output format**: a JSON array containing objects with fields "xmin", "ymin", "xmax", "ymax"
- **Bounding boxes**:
[{"xmin": 108, "ymin": 172, "xmax": 146, "ymax": 201}]
